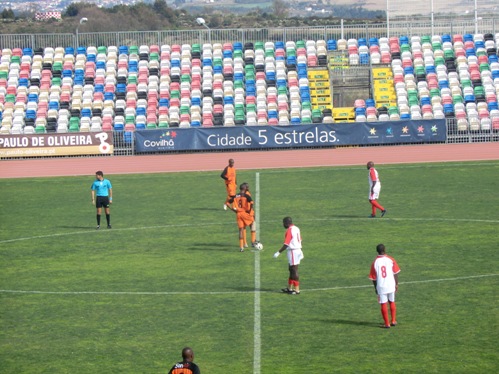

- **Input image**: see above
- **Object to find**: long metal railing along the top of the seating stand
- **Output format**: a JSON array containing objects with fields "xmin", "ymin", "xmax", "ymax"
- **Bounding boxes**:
[{"xmin": 0, "ymin": 18, "xmax": 499, "ymax": 49}]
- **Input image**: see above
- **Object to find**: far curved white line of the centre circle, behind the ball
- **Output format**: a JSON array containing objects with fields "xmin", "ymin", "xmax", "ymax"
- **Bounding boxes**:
[{"xmin": 0, "ymin": 216, "xmax": 499, "ymax": 244}]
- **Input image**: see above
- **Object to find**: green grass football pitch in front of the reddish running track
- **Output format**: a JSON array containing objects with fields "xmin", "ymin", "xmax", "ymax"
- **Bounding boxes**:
[{"xmin": 0, "ymin": 162, "xmax": 499, "ymax": 374}]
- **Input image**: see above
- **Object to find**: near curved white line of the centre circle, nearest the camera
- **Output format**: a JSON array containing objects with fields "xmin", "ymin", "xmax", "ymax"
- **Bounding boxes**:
[{"xmin": 0, "ymin": 274, "xmax": 499, "ymax": 296}]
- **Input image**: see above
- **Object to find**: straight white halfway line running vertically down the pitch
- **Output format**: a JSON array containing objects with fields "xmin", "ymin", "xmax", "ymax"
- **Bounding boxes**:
[{"xmin": 253, "ymin": 173, "xmax": 262, "ymax": 374}]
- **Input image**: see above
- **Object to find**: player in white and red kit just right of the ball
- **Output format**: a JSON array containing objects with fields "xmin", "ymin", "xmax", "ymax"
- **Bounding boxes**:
[{"xmin": 274, "ymin": 217, "xmax": 304, "ymax": 295}]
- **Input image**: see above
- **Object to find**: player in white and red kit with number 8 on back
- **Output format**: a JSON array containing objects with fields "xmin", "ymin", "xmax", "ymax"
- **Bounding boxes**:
[{"xmin": 369, "ymin": 244, "xmax": 400, "ymax": 328}]
